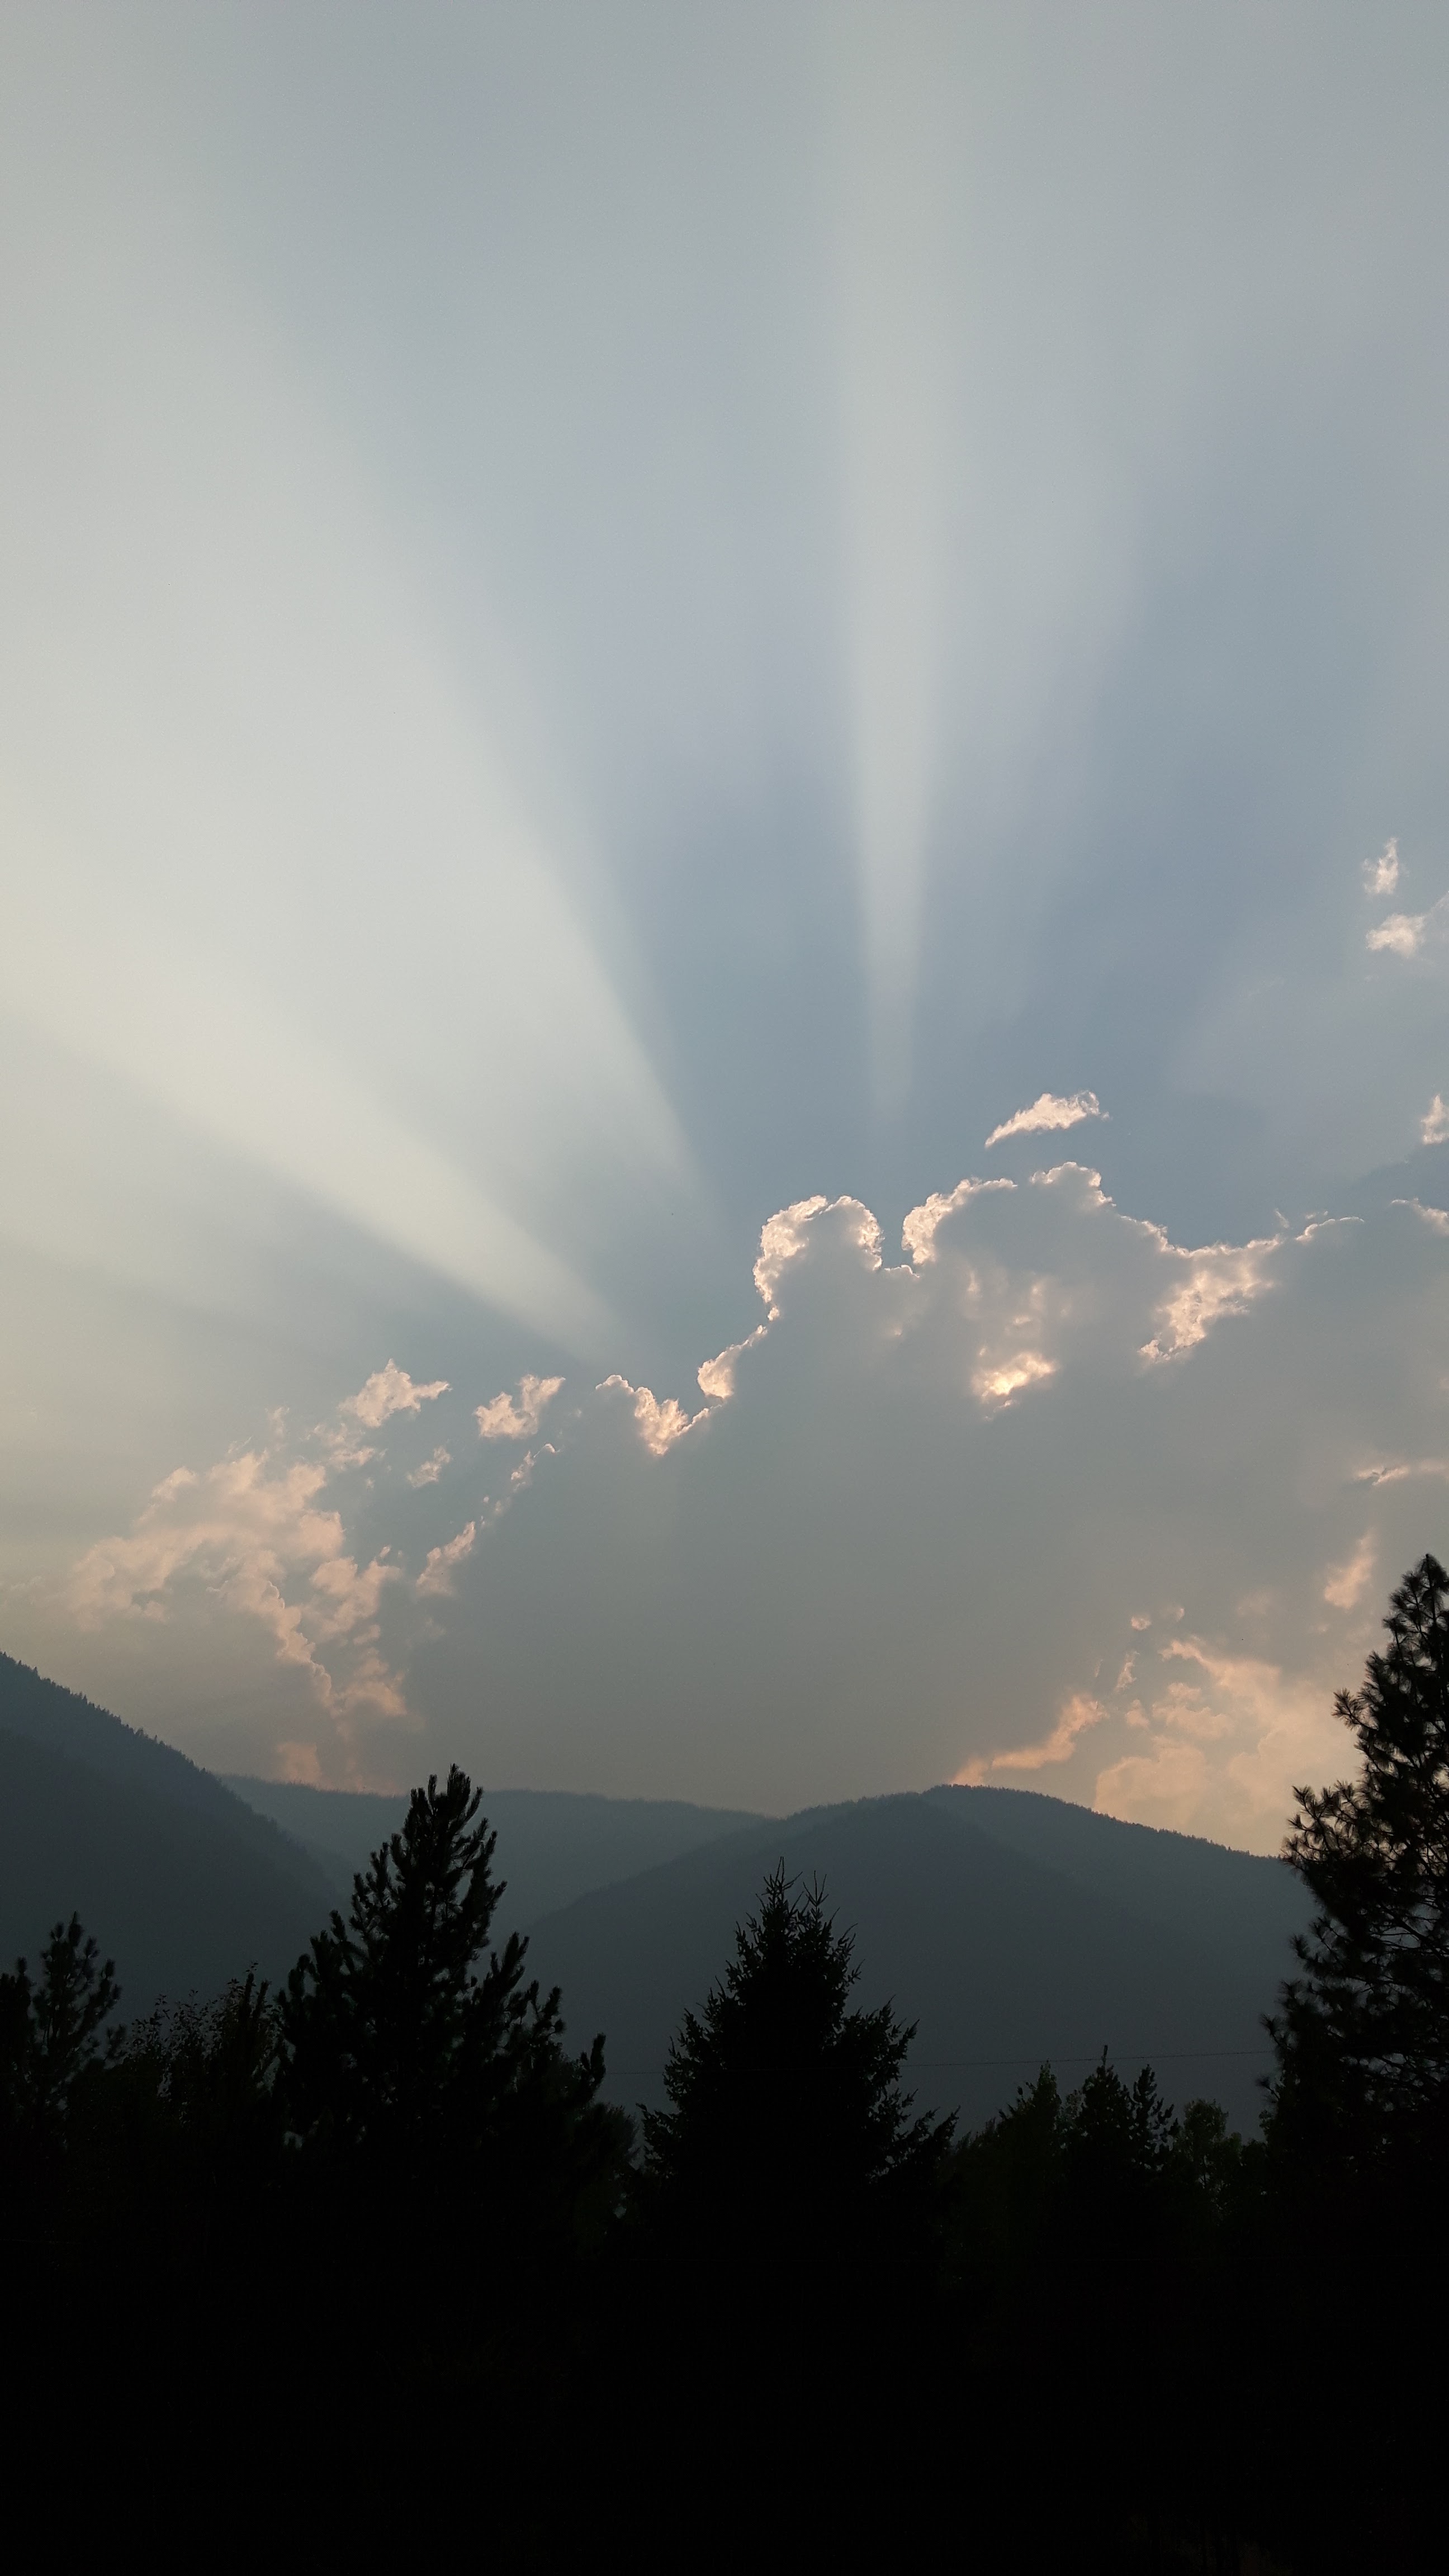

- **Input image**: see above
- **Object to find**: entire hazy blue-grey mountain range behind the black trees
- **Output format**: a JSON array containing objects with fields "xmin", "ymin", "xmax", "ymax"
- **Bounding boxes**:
[{"xmin": 0, "ymin": 1656, "xmax": 1310, "ymax": 2125}]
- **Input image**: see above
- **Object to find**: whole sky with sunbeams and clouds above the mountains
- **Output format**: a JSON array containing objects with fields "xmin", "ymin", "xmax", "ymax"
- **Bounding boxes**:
[{"xmin": 0, "ymin": 0, "xmax": 1449, "ymax": 1850}]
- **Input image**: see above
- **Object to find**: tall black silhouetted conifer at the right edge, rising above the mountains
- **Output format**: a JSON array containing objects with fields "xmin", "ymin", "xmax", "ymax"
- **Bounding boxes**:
[{"xmin": 1268, "ymin": 1556, "xmax": 1449, "ymax": 2174}]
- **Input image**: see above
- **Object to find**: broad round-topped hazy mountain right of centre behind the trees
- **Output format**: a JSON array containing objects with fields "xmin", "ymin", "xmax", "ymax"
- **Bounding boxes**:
[{"xmin": 520, "ymin": 1796, "xmax": 1307, "ymax": 2125}]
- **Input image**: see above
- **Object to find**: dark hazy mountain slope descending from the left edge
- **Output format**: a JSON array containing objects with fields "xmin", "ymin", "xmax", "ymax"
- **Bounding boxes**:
[{"xmin": 0, "ymin": 1654, "xmax": 333, "ymax": 2017}]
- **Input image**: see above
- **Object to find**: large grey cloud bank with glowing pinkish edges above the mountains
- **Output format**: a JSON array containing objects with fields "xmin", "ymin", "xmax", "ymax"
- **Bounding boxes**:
[{"xmin": 20, "ymin": 1162, "xmax": 1449, "ymax": 1850}]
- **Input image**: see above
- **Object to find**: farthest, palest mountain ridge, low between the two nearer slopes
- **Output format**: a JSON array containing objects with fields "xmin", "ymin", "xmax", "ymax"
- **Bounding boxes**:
[{"xmin": 224, "ymin": 1775, "xmax": 768, "ymax": 1927}]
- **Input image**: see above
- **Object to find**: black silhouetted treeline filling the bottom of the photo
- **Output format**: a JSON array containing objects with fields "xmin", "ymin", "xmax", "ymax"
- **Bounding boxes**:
[{"xmin": 0, "ymin": 1559, "xmax": 1449, "ymax": 2576}]
